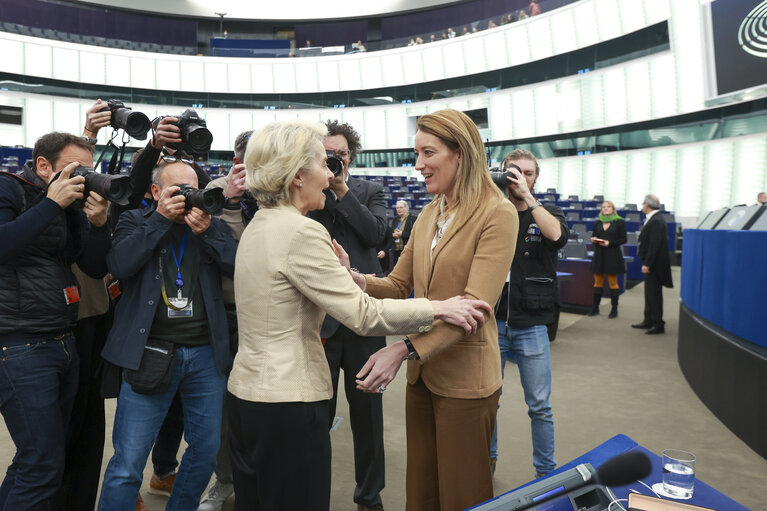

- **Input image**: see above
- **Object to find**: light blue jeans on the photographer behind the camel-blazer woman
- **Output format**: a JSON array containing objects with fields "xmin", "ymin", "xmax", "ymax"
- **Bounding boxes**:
[{"xmin": 490, "ymin": 321, "xmax": 557, "ymax": 475}]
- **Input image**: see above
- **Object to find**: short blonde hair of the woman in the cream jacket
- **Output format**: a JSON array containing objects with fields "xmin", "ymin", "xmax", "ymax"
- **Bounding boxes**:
[{"xmin": 245, "ymin": 120, "xmax": 327, "ymax": 208}]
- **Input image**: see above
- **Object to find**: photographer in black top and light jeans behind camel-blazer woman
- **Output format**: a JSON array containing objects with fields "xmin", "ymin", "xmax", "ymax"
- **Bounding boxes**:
[{"xmin": 490, "ymin": 149, "xmax": 569, "ymax": 476}]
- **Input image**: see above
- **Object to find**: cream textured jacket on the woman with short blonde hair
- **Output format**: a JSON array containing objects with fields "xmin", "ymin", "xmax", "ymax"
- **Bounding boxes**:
[{"xmin": 228, "ymin": 206, "xmax": 434, "ymax": 402}]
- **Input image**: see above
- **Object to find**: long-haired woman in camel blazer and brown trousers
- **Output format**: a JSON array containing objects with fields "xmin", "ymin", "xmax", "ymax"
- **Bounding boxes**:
[{"xmin": 352, "ymin": 110, "xmax": 519, "ymax": 511}]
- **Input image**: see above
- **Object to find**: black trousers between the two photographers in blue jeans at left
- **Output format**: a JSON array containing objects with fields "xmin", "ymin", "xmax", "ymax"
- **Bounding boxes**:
[{"xmin": 61, "ymin": 314, "xmax": 110, "ymax": 511}]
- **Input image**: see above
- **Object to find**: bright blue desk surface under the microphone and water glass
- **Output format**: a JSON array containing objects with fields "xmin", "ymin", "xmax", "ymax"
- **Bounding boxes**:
[{"xmin": 488, "ymin": 435, "xmax": 748, "ymax": 511}]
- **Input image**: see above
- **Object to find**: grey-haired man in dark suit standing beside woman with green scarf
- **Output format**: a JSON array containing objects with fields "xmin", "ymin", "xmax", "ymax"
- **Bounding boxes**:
[{"xmin": 631, "ymin": 195, "xmax": 674, "ymax": 335}]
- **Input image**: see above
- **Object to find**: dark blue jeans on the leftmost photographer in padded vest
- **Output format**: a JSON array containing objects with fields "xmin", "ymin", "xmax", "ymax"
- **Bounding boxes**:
[{"xmin": 0, "ymin": 335, "xmax": 79, "ymax": 511}]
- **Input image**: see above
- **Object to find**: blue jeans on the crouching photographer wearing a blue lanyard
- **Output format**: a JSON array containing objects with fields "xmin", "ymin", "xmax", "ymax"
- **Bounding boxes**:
[{"xmin": 99, "ymin": 345, "xmax": 226, "ymax": 511}]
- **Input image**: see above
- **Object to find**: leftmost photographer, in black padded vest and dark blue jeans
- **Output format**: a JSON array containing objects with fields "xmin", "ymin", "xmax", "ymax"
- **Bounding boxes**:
[{"xmin": 0, "ymin": 132, "xmax": 110, "ymax": 511}]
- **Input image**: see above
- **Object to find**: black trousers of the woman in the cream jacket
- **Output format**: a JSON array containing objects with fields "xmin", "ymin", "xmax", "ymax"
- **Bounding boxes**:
[{"xmin": 227, "ymin": 394, "xmax": 330, "ymax": 511}]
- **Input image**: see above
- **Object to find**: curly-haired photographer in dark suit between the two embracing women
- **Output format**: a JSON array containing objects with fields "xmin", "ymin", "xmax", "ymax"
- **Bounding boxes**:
[{"xmin": 309, "ymin": 121, "xmax": 388, "ymax": 511}]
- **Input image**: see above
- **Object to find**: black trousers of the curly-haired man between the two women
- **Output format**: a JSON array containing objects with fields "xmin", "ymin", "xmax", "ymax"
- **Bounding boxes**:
[{"xmin": 325, "ymin": 325, "xmax": 386, "ymax": 507}]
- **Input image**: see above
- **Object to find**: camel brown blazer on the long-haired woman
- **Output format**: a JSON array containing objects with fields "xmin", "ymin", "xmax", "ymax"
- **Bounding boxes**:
[{"xmin": 366, "ymin": 195, "xmax": 519, "ymax": 399}]
